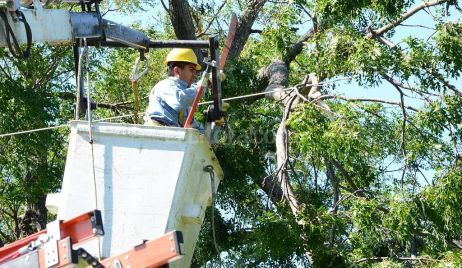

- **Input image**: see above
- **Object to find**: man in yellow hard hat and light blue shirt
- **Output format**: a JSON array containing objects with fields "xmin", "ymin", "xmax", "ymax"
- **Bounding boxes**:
[{"xmin": 145, "ymin": 48, "xmax": 204, "ymax": 133}]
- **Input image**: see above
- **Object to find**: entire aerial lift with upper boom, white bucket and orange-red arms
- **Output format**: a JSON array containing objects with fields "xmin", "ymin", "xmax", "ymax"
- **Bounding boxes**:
[{"xmin": 0, "ymin": 0, "xmax": 226, "ymax": 268}]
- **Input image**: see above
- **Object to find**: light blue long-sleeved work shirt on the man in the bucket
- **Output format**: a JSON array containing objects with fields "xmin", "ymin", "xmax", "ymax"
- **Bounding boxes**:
[{"xmin": 146, "ymin": 76, "xmax": 205, "ymax": 132}]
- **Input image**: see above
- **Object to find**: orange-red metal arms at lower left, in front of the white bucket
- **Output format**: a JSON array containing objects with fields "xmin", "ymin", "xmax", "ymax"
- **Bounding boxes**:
[{"xmin": 0, "ymin": 210, "xmax": 183, "ymax": 268}]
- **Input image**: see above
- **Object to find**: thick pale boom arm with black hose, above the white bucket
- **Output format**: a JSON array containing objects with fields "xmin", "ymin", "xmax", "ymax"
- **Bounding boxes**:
[{"xmin": 0, "ymin": 1, "xmax": 149, "ymax": 51}]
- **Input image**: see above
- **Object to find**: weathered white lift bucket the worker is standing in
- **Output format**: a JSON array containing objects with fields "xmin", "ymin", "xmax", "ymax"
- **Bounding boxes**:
[{"xmin": 52, "ymin": 121, "xmax": 222, "ymax": 267}]
